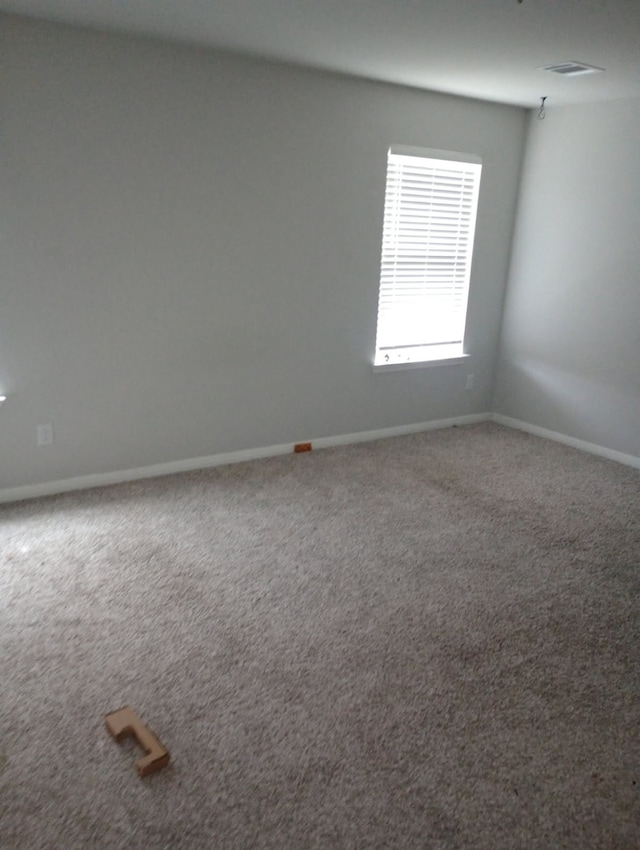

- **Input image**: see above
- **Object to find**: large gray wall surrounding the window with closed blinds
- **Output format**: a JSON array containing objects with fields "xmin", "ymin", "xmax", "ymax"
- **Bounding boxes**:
[{"xmin": 0, "ymin": 17, "xmax": 524, "ymax": 489}]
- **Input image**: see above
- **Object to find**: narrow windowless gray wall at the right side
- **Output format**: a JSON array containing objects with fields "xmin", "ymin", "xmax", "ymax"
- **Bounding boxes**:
[{"xmin": 495, "ymin": 99, "xmax": 640, "ymax": 457}]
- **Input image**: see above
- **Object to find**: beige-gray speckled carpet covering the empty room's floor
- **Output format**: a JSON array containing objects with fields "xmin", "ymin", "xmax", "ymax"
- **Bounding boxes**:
[{"xmin": 0, "ymin": 424, "xmax": 640, "ymax": 850}]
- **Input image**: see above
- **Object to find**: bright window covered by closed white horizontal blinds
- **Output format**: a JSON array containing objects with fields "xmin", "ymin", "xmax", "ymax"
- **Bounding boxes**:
[{"xmin": 374, "ymin": 146, "xmax": 482, "ymax": 366}]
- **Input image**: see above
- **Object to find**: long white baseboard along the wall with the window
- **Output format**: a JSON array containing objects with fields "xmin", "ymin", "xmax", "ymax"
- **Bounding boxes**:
[{"xmin": 0, "ymin": 413, "xmax": 491, "ymax": 504}]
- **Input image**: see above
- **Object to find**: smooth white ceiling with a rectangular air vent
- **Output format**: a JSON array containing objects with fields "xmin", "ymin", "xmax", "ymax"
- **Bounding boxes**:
[{"xmin": 0, "ymin": 0, "xmax": 640, "ymax": 109}]
